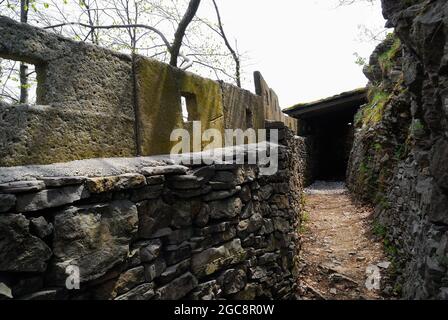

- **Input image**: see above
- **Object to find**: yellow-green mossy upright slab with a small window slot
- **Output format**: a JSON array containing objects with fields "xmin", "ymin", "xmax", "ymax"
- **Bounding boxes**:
[{"xmin": 135, "ymin": 57, "xmax": 224, "ymax": 155}]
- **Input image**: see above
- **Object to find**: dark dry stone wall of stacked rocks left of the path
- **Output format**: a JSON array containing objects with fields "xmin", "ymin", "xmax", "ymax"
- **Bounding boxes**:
[{"xmin": 0, "ymin": 122, "xmax": 304, "ymax": 300}]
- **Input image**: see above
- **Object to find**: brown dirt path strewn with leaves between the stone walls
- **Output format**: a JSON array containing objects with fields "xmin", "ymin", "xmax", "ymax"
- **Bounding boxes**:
[{"xmin": 299, "ymin": 182, "xmax": 389, "ymax": 300}]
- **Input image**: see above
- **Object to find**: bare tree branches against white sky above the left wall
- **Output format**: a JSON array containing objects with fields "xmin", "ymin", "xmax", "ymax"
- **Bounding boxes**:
[{"xmin": 0, "ymin": 0, "xmax": 245, "ymax": 104}]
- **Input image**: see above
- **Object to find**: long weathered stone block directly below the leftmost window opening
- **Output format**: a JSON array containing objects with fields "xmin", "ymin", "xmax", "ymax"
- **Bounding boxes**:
[{"xmin": 0, "ymin": 105, "xmax": 136, "ymax": 166}]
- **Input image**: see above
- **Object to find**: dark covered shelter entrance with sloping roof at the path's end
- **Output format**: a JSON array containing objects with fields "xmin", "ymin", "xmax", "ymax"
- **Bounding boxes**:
[{"xmin": 284, "ymin": 88, "xmax": 367, "ymax": 183}]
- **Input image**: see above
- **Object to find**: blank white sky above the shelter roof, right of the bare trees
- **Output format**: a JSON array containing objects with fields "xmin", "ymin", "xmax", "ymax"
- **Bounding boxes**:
[{"xmin": 198, "ymin": 0, "xmax": 385, "ymax": 108}]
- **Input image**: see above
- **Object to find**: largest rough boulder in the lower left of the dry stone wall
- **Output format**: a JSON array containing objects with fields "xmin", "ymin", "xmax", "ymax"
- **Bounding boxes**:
[{"xmin": 53, "ymin": 201, "xmax": 138, "ymax": 282}]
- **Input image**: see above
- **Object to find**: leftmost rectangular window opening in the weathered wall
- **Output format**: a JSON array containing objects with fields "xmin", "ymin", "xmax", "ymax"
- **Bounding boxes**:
[{"xmin": 0, "ymin": 58, "xmax": 37, "ymax": 105}]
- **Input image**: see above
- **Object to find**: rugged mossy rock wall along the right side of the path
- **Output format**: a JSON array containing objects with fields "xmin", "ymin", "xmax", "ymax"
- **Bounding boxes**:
[{"xmin": 348, "ymin": 0, "xmax": 448, "ymax": 299}]
